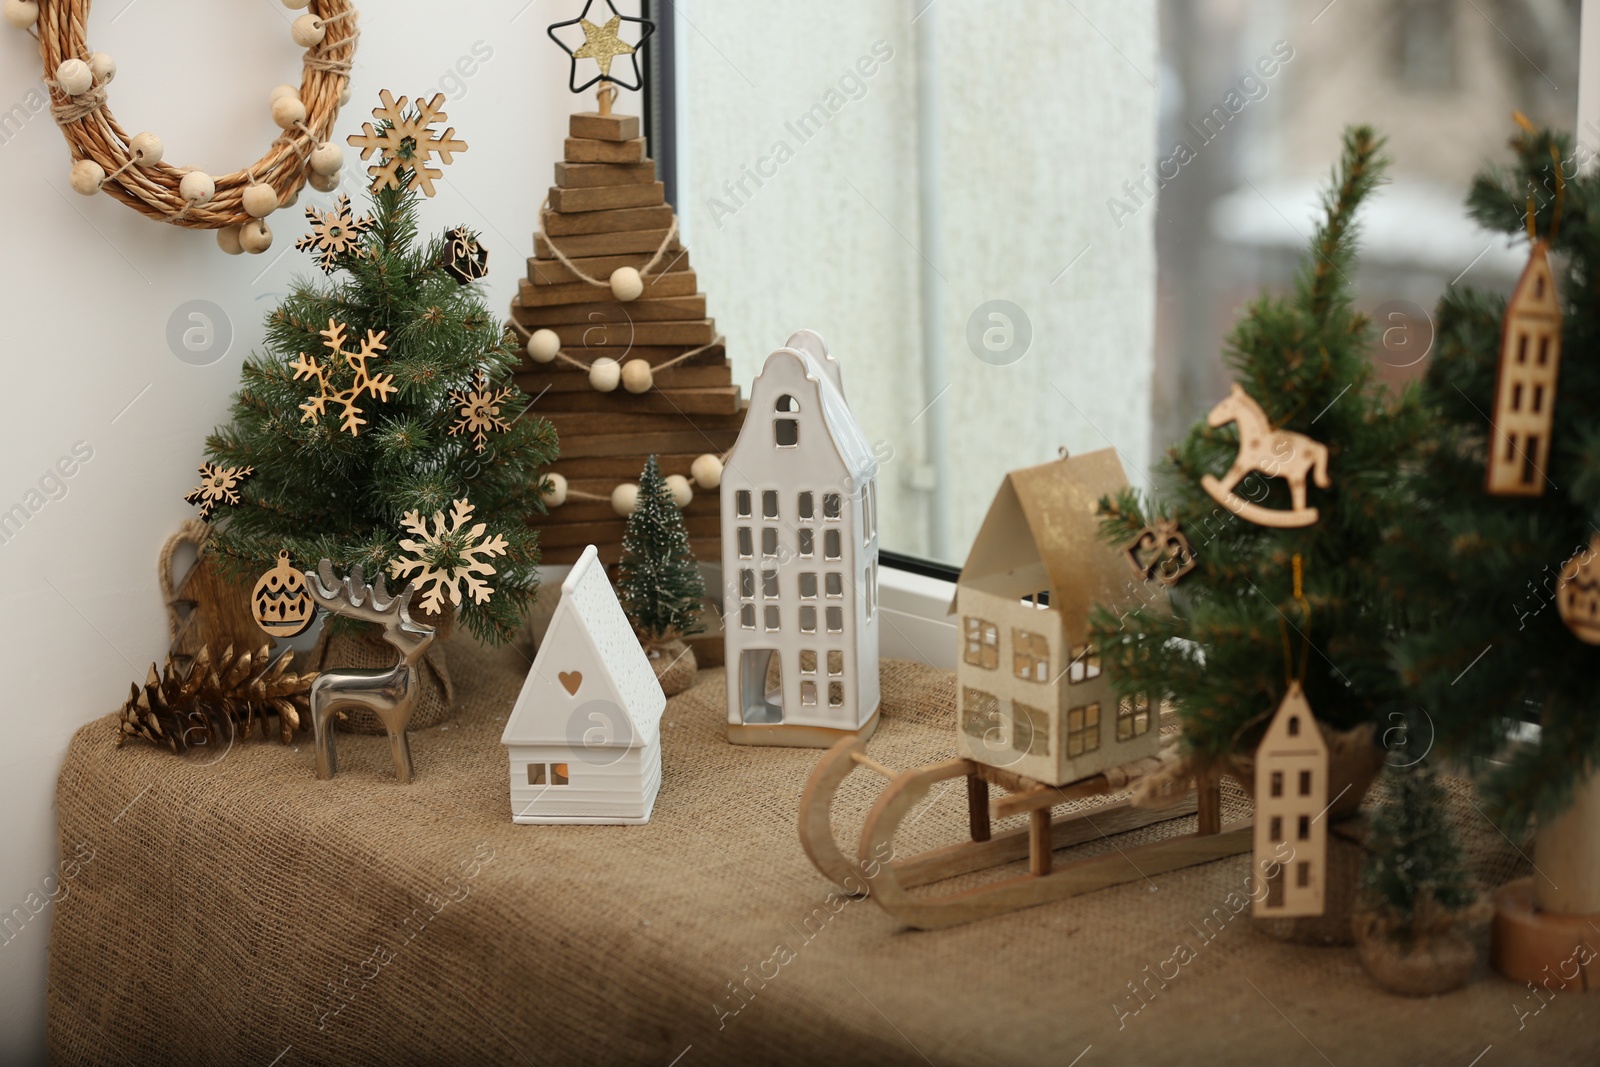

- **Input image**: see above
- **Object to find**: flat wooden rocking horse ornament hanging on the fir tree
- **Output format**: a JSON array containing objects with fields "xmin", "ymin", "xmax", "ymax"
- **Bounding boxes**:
[{"xmin": 1200, "ymin": 382, "xmax": 1333, "ymax": 528}]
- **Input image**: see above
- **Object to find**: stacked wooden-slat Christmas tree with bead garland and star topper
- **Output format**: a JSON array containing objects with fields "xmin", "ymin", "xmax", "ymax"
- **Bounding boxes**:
[{"xmin": 510, "ymin": 2, "xmax": 744, "ymax": 563}]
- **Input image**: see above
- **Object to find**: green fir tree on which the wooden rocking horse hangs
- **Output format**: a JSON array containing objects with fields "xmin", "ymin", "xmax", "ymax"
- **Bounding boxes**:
[{"xmin": 1093, "ymin": 126, "xmax": 1421, "ymax": 773}]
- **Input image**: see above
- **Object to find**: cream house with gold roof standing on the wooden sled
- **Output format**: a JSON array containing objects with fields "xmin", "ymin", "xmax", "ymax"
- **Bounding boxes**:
[{"xmin": 950, "ymin": 448, "xmax": 1166, "ymax": 785}]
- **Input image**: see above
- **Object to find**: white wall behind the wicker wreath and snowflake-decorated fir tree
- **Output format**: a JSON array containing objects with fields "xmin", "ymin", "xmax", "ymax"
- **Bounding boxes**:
[{"xmin": 0, "ymin": 0, "xmax": 604, "ymax": 1062}]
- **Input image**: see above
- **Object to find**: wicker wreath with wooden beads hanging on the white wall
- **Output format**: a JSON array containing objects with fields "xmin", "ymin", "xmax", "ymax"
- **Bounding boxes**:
[{"xmin": 5, "ymin": 0, "xmax": 360, "ymax": 253}]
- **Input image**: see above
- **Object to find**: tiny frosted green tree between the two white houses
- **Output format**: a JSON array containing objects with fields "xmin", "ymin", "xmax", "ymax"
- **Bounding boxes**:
[{"xmin": 616, "ymin": 456, "xmax": 706, "ymax": 643}]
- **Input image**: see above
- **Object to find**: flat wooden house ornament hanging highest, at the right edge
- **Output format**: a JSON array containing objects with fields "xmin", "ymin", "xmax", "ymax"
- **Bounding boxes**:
[{"xmin": 1486, "ymin": 240, "xmax": 1562, "ymax": 496}]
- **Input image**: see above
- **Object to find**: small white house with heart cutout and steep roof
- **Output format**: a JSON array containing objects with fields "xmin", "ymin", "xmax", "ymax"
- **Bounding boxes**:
[{"xmin": 501, "ymin": 545, "xmax": 667, "ymax": 824}]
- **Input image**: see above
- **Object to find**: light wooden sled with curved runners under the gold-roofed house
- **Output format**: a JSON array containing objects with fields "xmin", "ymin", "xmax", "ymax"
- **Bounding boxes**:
[{"xmin": 800, "ymin": 737, "xmax": 1251, "ymax": 929}]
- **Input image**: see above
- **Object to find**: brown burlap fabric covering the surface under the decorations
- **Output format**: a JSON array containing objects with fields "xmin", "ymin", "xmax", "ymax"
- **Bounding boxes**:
[{"xmin": 50, "ymin": 641, "xmax": 1600, "ymax": 1067}]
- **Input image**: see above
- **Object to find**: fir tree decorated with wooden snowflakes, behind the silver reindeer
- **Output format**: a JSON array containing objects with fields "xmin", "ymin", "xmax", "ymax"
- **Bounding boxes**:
[{"xmin": 206, "ymin": 168, "xmax": 557, "ymax": 641}]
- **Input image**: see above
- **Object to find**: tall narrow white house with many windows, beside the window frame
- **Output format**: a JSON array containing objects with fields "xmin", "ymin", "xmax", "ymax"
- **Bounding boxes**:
[{"xmin": 722, "ymin": 330, "xmax": 878, "ymax": 747}]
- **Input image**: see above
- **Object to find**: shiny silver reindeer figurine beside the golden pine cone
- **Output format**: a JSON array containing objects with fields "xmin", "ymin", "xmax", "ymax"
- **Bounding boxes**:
[{"xmin": 306, "ymin": 560, "xmax": 434, "ymax": 785}]
